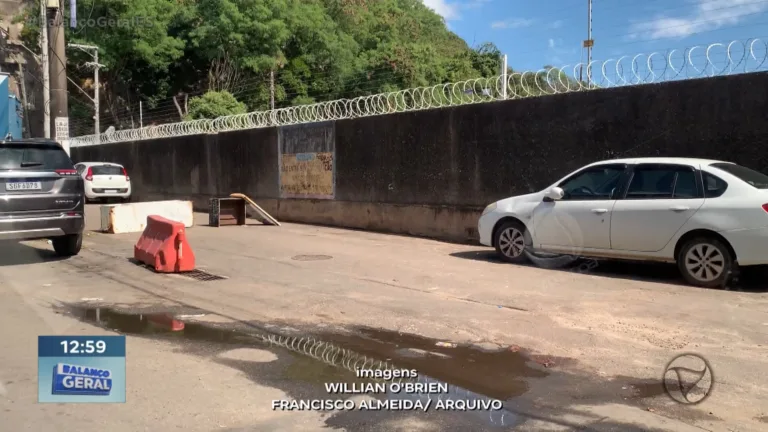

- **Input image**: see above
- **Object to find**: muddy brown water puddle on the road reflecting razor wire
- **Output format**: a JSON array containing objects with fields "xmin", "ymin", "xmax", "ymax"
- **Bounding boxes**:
[{"xmin": 60, "ymin": 305, "xmax": 565, "ymax": 430}]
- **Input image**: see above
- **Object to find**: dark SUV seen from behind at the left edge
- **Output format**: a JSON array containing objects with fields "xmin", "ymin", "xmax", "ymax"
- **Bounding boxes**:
[{"xmin": 0, "ymin": 140, "xmax": 85, "ymax": 256}]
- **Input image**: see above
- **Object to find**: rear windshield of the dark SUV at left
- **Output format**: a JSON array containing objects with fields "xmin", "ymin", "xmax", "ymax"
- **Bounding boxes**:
[{"xmin": 0, "ymin": 143, "xmax": 74, "ymax": 170}]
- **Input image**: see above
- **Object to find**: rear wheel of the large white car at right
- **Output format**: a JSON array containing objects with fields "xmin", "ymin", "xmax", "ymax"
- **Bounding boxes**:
[{"xmin": 677, "ymin": 237, "xmax": 733, "ymax": 288}]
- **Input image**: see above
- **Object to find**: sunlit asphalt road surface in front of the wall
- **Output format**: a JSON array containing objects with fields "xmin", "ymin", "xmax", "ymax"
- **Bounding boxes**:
[{"xmin": 0, "ymin": 206, "xmax": 768, "ymax": 431}]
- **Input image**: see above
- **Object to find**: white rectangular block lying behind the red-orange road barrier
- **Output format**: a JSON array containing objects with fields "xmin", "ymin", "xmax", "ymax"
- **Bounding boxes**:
[{"xmin": 101, "ymin": 201, "xmax": 194, "ymax": 234}]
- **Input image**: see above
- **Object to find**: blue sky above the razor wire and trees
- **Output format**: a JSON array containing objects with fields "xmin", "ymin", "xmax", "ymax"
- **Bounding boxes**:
[{"xmin": 423, "ymin": 0, "xmax": 768, "ymax": 70}]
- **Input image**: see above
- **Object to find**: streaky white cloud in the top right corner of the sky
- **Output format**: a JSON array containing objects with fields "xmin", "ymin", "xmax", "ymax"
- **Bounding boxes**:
[{"xmin": 628, "ymin": 0, "xmax": 768, "ymax": 39}]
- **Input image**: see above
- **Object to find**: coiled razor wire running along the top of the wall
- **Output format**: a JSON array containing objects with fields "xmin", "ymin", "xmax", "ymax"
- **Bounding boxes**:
[{"xmin": 70, "ymin": 39, "xmax": 768, "ymax": 147}]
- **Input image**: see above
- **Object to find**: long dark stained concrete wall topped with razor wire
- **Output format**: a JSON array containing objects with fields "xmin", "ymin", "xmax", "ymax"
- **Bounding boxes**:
[{"xmin": 72, "ymin": 73, "xmax": 768, "ymax": 245}]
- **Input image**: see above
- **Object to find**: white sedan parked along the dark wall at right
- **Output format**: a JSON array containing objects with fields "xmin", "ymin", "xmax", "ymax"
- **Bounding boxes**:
[{"xmin": 478, "ymin": 158, "xmax": 768, "ymax": 287}]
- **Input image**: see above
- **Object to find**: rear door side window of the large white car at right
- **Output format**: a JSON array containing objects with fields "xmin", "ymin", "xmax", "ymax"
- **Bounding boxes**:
[{"xmin": 626, "ymin": 165, "xmax": 699, "ymax": 199}]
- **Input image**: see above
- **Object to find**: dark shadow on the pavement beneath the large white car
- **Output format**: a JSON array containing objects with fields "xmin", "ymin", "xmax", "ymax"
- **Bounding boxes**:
[{"xmin": 450, "ymin": 249, "xmax": 768, "ymax": 293}]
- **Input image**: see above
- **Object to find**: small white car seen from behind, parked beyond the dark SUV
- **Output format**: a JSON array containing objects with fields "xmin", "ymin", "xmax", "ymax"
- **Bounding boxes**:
[{"xmin": 75, "ymin": 162, "xmax": 131, "ymax": 201}]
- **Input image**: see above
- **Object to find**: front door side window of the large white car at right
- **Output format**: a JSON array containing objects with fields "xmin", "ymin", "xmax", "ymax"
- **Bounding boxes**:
[{"xmin": 560, "ymin": 165, "xmax": 625, "ymax": 200}]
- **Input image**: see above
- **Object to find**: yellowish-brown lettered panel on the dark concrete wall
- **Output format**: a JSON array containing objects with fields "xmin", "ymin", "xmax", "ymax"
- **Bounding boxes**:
[{"xmin": 280, "ymin": 152, "xmax": 333, "ymax": 199}]
